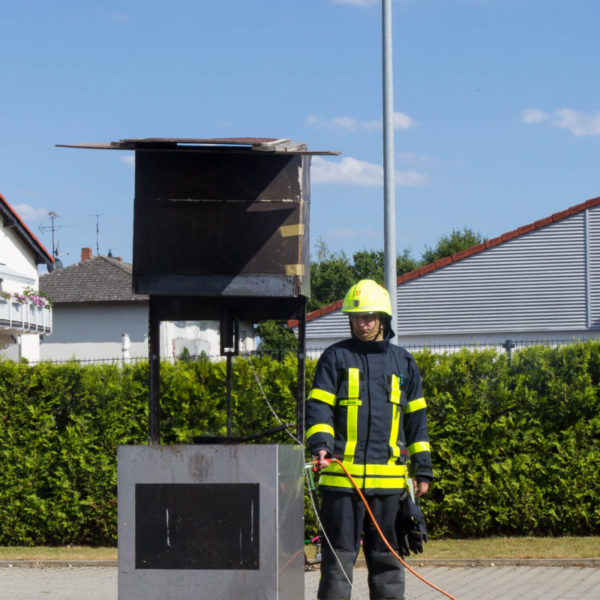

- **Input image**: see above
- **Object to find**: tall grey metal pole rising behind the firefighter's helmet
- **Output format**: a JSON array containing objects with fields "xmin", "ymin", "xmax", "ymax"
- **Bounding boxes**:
[{"xmin": 381, "ymin": 0, "xmax": 398, "ymax": 343}]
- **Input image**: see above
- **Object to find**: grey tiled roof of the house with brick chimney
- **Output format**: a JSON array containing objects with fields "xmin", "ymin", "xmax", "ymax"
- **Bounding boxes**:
[{"xmin": 40, "ymin": 256, "xmax": 148, "ymax": 304}]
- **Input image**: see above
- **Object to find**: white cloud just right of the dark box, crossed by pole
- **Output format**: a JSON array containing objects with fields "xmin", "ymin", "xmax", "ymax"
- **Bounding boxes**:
[{"xmin": 311, "ymin": 156, "xmax": 428, "ymax": 186}]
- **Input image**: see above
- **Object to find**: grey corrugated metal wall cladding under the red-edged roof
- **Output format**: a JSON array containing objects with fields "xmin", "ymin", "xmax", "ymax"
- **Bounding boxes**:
[{"xmin": 306, "ymin": 212, "xmax": 600, "ymax": 344}]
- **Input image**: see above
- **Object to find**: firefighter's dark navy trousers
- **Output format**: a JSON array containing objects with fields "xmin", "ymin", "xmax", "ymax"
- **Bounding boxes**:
[{"xmin": 318, "ymin": 492, "xmax": 405, "ymax": 600}]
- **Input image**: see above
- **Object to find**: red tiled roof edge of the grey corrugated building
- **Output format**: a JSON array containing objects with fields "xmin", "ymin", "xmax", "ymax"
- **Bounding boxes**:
[{"xmin": 288, "ymin": 196, "xmax": 600, "ymax": 328}]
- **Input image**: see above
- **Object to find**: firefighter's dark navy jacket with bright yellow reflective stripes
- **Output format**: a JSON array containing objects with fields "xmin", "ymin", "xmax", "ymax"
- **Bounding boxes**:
[{"xmin": 306, "ymin": 332, "xmax": 432, "ymax": 494}]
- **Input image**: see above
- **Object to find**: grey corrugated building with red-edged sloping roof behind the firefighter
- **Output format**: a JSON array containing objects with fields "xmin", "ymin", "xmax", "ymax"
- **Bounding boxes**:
[{"xmin": 290, "ymin": 198, "xmax": 600, "ymax": 355}]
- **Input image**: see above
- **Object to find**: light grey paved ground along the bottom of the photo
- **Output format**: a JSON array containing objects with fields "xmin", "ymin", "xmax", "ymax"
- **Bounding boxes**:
[{"xmin": 0, "ymin": 566, "xmax": 600, "ymax": 600}]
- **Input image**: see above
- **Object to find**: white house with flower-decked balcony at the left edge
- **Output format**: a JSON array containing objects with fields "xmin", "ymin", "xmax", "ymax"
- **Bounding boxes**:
[{"xmin": 0, "ymin": 194, "xmax": 54, "ymax": 362}]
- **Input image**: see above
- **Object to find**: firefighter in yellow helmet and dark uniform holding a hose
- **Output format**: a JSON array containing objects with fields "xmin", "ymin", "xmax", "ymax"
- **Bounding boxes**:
[{"xmin": 306, "ymin": 279, "xmax": 432, "ymax": 600}]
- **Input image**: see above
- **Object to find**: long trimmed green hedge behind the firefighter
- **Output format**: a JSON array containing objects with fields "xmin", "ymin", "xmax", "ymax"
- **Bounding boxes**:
[{"xmin": 0, "ymin": 342, "xmax": 600, "ymax": 545}]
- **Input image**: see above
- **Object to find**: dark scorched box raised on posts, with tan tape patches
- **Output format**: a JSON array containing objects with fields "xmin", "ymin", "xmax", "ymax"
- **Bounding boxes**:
[{"xmin": 133, "ymin": 146, "xmax": 310, "ymax": 298}]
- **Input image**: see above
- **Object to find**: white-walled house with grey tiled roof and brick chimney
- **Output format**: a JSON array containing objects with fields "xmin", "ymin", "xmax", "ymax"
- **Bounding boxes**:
[{"xmin": 40, "ymin": 248, "xmax": 254, "ymax": 362}]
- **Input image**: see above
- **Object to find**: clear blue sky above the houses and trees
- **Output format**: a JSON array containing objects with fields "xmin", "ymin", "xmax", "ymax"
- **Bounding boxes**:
[{"xmin": 0, "ymin": 0, "xmax": 600, "ymax": 264}]
